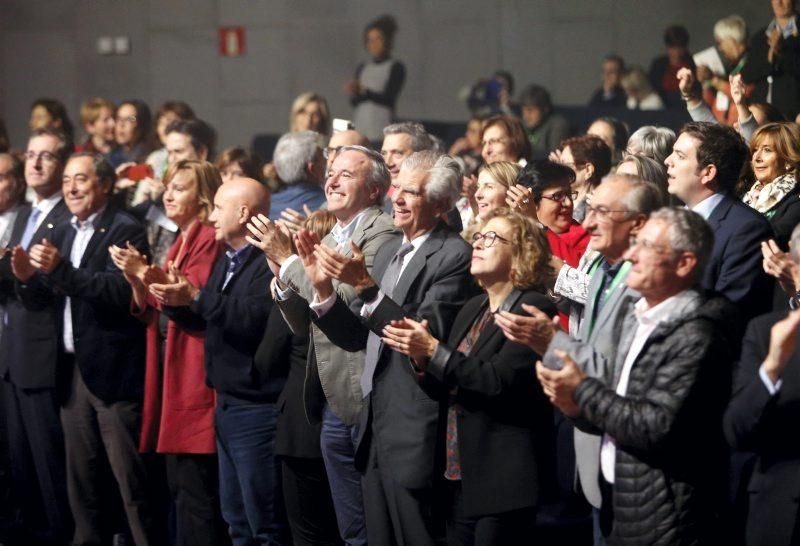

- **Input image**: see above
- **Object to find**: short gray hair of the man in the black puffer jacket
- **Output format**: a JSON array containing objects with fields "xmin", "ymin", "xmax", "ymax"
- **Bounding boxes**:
[{"xmin": 650, "ymin": 207, "xmax": 714, "ymax": 283}]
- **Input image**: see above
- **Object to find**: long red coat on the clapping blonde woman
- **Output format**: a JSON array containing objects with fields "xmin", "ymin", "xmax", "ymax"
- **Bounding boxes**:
[{"xmin": 139, "ymin": 223, "xmax": 222, "ymax": 453}]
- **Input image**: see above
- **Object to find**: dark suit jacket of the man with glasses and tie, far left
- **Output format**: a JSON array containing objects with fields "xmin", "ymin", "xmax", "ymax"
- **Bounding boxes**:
[{"xmin": 0, "ymin": 199, "xmax": 71, "ymax": 389}]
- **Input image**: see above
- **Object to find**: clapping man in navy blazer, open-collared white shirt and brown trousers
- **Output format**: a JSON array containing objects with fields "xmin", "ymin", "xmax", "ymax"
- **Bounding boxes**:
[{"xmin": 11, "ymin": 153, "xmax": 153, "ymax": 544}]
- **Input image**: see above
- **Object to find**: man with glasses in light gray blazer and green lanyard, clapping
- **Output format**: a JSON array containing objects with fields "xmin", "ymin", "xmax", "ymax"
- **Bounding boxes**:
[{"xmin": 497, "ymin": 175, "xmax": 661, "ymax": 538}]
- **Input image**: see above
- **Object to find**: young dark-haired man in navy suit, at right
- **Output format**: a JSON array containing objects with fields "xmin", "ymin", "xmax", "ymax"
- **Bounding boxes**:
[{"xmin": 664, "ymin": 122, "xmax": 773, "ymax": 326}]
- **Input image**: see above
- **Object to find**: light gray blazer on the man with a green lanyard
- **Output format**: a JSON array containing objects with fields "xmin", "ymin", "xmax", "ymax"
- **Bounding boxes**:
[{"xmin": 545, "ymin": 260, "xmax": 640, "ymax": 508}]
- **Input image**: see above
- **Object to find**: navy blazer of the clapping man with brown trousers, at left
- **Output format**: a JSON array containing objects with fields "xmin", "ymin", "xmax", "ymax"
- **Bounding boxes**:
[{"xmin": 19, "ymin": 206, "xmax": 148, "ymax": 402}]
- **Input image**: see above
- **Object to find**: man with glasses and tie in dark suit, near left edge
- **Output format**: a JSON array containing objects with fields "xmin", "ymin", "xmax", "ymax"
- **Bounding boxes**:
[{"xmin": 0, "ymin": 129, "xmax": 72, "ymax": 542}]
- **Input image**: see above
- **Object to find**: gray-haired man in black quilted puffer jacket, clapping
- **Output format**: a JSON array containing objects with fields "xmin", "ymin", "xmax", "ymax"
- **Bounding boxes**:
[{"xmin": 536, "ymin": 208, "xmax": 732, "ymax": 544}]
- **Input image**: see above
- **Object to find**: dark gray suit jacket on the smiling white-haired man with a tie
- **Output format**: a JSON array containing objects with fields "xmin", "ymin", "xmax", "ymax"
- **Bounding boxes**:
[{"xmin": 314, "ymin": 222, "xmax": 478, "ymax": 489}]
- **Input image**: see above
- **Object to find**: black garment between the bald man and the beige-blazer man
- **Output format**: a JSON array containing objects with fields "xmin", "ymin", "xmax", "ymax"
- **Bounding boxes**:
[{"xmin": 255, "ymin": 305, "xmax": 322, "ymax": 459}]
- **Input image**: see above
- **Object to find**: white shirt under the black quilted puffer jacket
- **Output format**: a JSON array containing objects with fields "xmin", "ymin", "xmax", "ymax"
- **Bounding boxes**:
[{"xmin": 600, "ymin": 290, "xmax": 694, "ymax": 483}]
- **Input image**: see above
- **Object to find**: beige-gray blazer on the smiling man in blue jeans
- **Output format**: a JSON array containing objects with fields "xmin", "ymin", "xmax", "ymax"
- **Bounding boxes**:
[{"xmin": 277, "ymin": 207, "xmax": 396, "ymax": 425}]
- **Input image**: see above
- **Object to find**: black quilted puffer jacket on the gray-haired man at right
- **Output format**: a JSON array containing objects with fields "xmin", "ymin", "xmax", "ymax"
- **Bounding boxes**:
[{"xmin": 574, "ymin": 293, "xmax": 734, "ymax": 544}]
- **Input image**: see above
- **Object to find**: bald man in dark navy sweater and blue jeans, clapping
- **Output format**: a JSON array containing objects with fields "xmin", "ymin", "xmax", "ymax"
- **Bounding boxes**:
[{"xmin": 151, "ymin": 178, "xmax": 289, "ymax": 544}]
